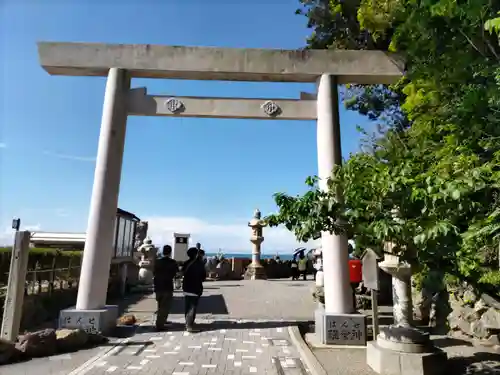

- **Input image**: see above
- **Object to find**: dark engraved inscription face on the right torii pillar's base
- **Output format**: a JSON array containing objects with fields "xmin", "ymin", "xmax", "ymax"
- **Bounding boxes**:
[{"xmin": 325, "ymin": 315, "xmax": 366, "ymax": 346}]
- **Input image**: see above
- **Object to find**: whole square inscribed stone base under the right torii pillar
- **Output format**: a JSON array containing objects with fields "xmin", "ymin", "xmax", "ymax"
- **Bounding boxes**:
[{"xmin": 314, "ymin": 307, "xmax": 367, "ymax": 346}]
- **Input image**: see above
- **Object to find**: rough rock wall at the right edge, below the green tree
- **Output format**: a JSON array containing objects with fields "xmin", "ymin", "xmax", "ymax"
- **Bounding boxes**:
[{"xmin": 448, "ymin": 287, "xmax": 500, "ymax": 346}]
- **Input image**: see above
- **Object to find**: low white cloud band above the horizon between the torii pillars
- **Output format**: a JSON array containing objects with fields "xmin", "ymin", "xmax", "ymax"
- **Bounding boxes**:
[{"xmin": 143, "ymin": 216, "xmax": 317, "ymax": 254}]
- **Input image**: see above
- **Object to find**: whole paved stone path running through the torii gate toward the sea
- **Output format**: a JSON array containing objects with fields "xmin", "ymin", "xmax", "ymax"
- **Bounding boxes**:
[{"xmin": 0, "ymin": 280, "xmax": 315, "ymax": 375}]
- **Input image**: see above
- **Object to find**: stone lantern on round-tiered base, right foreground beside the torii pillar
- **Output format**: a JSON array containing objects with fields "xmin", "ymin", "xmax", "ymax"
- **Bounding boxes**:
[{"xmin": 366, "ymin": 254, "xmax": 447, "ymax": 375}]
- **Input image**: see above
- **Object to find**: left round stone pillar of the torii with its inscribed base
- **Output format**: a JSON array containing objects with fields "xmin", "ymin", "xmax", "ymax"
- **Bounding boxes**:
[{"xmin": 59, "ymin": 68, "xmax": 130, "ymax": 331}]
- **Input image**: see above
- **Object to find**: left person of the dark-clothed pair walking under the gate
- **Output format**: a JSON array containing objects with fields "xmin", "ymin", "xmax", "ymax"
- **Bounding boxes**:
[{"xmin": 153, "ymin": 245, "xmax": 179, "ymax": 331}]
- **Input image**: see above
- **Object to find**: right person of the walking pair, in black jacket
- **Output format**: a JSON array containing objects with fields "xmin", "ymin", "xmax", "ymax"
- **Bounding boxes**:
[{"xmin": 182, "ymin": 247, "xmax": 207, "ymax": 332}]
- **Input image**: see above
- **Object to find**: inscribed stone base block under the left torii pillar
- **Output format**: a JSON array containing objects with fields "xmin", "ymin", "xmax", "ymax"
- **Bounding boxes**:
[{"xmin": 59, "ymin": 305, "xmax": 118, "ymax": 334}]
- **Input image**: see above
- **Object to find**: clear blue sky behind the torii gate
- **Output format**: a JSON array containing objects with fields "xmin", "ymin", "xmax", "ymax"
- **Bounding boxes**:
[{"xmin": 0, "ymin": 0, "xmax": 376, "ymax": 253}]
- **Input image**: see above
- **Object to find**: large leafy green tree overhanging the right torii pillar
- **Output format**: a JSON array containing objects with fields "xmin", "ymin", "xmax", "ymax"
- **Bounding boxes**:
[{"xmin": 269, "ymin": 0, "xmax": 500, "ymax": 294}]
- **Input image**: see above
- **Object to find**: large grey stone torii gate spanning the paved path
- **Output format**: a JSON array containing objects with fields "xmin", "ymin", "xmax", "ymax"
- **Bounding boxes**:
[{"xmin": 38, "ymin": 42, "xmax": 403, "ymax": 340}]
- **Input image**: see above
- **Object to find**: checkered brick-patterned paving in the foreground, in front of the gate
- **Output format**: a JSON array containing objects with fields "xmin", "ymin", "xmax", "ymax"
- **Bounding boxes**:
[{"xmin": 61, "ymin": 320, "xmax": 308, "ymax": 375}]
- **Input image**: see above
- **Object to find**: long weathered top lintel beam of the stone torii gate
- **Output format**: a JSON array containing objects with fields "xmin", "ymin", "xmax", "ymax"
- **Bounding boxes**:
[{"xmin": 38, "ymin": 42, "xmax": 404, "ymax": 84}]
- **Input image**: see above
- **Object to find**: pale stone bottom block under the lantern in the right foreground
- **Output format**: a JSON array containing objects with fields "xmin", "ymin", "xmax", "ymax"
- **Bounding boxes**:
[{"xmin": 366, "ymin": 341, "xmax": 447, "ymax": 375}]
